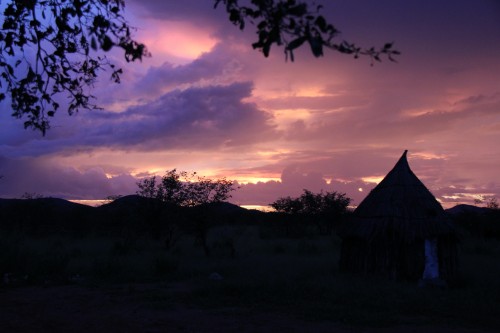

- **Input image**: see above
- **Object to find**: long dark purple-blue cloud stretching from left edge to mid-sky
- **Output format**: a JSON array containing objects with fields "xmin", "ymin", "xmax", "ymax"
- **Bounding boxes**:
[{"xmin": 3, "ymin": 82, "xmax": 279, "ymax": 156}]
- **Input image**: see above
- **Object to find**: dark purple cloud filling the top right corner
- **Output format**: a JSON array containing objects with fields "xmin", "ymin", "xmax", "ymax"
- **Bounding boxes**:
[{"xmin": 323, "ymin": 0, "xmax": 500, "ymax": 62}]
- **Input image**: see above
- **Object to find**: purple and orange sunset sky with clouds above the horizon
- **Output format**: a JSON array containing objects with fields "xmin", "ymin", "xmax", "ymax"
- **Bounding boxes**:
[{"xmin": 0, "ymin": 0, "xmax": 500, "ymax": 208}]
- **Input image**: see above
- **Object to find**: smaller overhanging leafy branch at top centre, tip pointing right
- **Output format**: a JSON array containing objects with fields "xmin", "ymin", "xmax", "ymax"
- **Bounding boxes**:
[{"xmin": 215, "ymin": 0, "xmax": 400, "ymax": 64}]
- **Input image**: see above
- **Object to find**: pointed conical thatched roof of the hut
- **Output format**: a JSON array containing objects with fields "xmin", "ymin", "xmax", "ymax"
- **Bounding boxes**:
[{"xmin": 341, "ymin": 150, "xmax": 454, "ymax": 242}]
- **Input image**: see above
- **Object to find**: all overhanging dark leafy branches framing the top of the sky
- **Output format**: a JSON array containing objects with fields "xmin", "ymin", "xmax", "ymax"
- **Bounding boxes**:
[{"xmin": 0, "ymin": 0, "xmax": 399, "ymax": 135}]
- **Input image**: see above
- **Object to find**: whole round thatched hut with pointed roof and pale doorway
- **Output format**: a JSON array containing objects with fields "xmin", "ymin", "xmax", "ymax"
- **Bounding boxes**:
[{"xmin": 339, "ymin": 150, "xmax": 457, "ymax": 281}]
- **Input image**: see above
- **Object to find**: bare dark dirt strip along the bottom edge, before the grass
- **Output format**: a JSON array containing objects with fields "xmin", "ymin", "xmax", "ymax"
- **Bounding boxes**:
[{"xmin": 0, "ymin": 283, "xmax": 488, "ymax": 333}]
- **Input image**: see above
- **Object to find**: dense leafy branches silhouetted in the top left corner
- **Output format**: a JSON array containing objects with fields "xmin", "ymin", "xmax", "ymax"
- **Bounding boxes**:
[{"xmin": 0, "ymin": 0, "xmax": 149, "ymax": 134}]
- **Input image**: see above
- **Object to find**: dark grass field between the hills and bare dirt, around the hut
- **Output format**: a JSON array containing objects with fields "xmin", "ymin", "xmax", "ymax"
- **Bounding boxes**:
[{"xmin": 0, "ymin": 222, "xmax": 500, "ymax": 329}]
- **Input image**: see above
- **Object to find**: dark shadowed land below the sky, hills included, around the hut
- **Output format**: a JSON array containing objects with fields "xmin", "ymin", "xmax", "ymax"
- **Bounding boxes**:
[{"xmin": 0, "ymin": 197, "xmax": 500, "ymax": 333}]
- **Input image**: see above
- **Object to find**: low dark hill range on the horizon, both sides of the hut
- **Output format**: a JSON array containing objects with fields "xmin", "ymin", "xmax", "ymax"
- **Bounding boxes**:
[{"xmin": 6, "ymin": 195, "xmax": 500, "ymax": 239}]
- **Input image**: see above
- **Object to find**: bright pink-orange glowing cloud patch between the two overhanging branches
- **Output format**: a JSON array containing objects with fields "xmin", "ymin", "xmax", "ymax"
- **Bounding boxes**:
[{"xmin": 137, "ymin": 19, "xmax": 217, "ymax": 64}]
